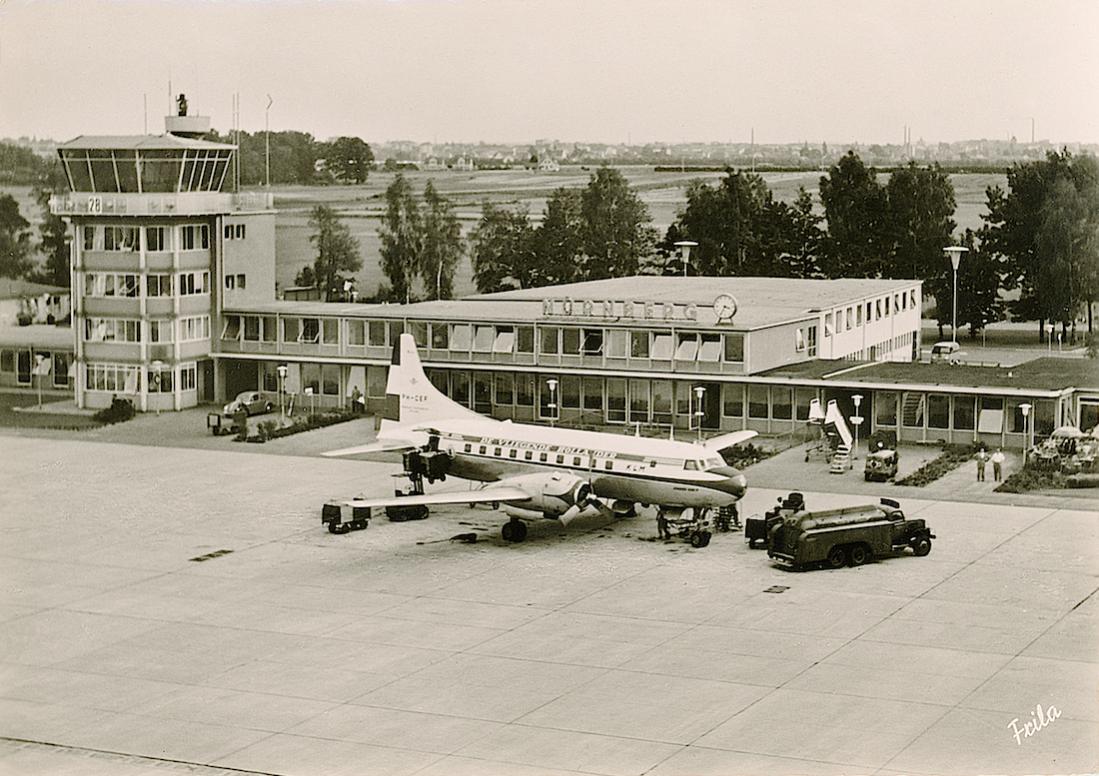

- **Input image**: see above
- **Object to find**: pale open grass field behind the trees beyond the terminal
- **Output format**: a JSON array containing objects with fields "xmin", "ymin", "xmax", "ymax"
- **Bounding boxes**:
[{"xmin": 2, "ymin": 166, "xmax": 1006, "ymax": 295}]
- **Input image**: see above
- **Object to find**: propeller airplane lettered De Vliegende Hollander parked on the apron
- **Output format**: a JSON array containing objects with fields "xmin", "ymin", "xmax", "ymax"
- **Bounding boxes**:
[{"xmin": 322, "ymin": 333, "xmax": 757, "ymax": 546}]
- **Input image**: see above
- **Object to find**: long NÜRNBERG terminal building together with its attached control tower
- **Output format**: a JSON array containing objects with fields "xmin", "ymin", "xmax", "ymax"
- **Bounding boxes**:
[{"xmin": 30, "ymin": 98, "xmax": 1099, "ymax": 447}]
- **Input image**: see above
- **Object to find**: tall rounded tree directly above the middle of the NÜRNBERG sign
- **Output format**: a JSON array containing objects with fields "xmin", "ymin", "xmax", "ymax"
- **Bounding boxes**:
[{"xmin": 580, "ymin": 166, "xmax": 656, "ymax": 280}]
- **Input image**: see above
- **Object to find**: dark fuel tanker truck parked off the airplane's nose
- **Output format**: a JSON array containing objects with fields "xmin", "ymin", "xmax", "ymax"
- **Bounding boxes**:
[{"xmin": 767, "ymin": 499, "xmax": 935, "ymax": 568}]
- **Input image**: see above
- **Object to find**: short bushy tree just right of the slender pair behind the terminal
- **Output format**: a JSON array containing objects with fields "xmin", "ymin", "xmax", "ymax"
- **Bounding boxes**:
[{"xmin": 469, "ymin": 200, "xmax": 535, "ymax": 293}]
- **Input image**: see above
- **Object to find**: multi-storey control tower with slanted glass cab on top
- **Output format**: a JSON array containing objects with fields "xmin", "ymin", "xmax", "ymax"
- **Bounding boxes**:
[{"xmin": 49, "ymin": 95, "xmax": 275, "ymax": 411}]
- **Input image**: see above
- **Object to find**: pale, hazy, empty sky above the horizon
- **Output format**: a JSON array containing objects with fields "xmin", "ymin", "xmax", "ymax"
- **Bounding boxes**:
[{"xmin": 0, "ymin": 0, "xmax": 1099, "ymax": 144}]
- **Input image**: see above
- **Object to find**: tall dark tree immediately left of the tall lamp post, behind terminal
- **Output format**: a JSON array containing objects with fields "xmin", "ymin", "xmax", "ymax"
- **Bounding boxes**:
[{"xmin": 885, "ymin": 162, "xmax": 956, "ymax": 280}]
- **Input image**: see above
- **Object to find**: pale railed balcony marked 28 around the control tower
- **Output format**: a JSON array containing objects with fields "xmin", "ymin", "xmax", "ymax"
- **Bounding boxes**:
[{"xmin": 49, "ymin": 191, "xmax": 275, "ymax": 217}]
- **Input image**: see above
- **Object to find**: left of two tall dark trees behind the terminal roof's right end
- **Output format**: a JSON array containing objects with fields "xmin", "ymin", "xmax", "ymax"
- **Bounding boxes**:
[{"xmin": 820, "ymin": 151, "xmax": 889, "ymax": 277}]
